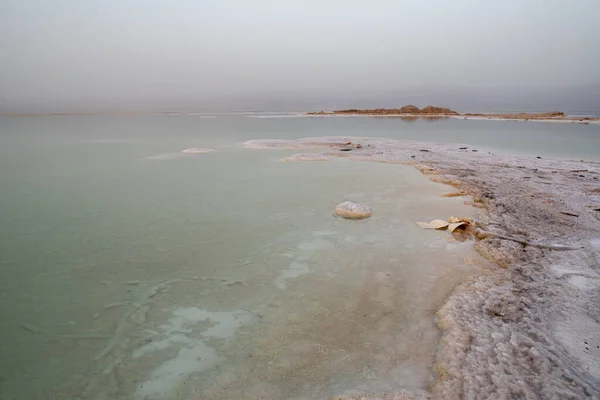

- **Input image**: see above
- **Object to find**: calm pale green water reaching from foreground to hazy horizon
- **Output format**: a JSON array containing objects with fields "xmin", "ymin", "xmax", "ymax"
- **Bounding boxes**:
[{"xmin": 0, "ymin": 115, "xmax": 600, "ymax": 399}]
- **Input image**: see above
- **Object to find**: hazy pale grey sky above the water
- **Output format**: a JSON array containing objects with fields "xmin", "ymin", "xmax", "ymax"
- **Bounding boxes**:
[{"xmin": 0, "ymin": 0, "xmax": 600, "ymax": 108}]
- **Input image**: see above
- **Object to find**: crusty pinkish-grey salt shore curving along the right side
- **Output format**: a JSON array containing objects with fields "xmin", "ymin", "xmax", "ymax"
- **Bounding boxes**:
[{"xmin": 245, "ymin": 137, "xmax": 600, "ymax": 399}]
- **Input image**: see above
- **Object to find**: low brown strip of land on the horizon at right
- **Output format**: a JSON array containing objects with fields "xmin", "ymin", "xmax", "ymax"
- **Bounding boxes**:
[{"xmin": 307, "ymin": 104, "xmax": 600, "ymax": 123}]
